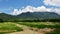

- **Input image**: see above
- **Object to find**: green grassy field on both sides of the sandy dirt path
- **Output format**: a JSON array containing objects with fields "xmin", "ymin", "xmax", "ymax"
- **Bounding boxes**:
[{"xmin": 0, "ymin": 22, "xmax": 60, "ymax": 34}]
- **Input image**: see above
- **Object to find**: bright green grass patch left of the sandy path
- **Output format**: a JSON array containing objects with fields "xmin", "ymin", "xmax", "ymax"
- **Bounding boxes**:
[{"xmin": 0, "ymin": 22, "xmax": 22, "ymax": 34}]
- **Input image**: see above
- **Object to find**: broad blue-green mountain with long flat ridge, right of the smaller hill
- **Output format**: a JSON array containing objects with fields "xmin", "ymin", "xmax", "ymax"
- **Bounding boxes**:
[{"xmin": 17, "ymin": 12, "xmax": 60, "ymax": 19}]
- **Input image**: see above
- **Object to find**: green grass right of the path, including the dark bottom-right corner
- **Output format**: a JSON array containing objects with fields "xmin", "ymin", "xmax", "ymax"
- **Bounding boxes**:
[{"xmin": 18, "ymin": 22, "xmax": 60, "ymax": 34}]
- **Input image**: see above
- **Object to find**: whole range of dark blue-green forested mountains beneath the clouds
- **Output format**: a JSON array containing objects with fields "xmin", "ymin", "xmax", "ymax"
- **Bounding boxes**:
[{"xmin": 0, "ymin": 12, "xmax": 60, "ymax": 21}]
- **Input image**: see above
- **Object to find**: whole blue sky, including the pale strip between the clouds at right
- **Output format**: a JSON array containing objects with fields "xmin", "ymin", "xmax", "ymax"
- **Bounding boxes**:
[{"xmin": 0, "ymin": 0, "xmax": 60, "ymax": 14}]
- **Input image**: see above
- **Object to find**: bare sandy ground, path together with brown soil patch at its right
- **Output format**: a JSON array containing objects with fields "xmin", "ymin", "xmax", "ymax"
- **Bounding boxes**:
[{"xmin": 10, "ymin": 23, "xmax": 53, "ymax": 34}]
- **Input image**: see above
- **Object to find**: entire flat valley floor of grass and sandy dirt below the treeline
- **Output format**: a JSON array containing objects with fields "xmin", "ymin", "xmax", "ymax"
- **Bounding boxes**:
[{"xmin": 0, "ymin": 22, "xmax": 60, "ymax": 34}]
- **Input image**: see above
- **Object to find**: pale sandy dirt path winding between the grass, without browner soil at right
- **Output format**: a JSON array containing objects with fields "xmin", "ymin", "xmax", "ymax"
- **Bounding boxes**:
[{"xmin": 10, "ymin": 23, "xmax": 45, "ymax": 34}]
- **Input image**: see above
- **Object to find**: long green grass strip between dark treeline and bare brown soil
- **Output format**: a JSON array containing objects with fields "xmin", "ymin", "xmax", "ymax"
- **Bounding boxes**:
[{"xmin": 18, "ymin": 22, "xmax": 60, "ymax": 29}]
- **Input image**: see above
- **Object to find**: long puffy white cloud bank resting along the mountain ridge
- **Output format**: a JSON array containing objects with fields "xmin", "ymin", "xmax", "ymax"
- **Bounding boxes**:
[{"xmin": 13, "ymin": 6, "xmax": 60, "ymax": 15}]
